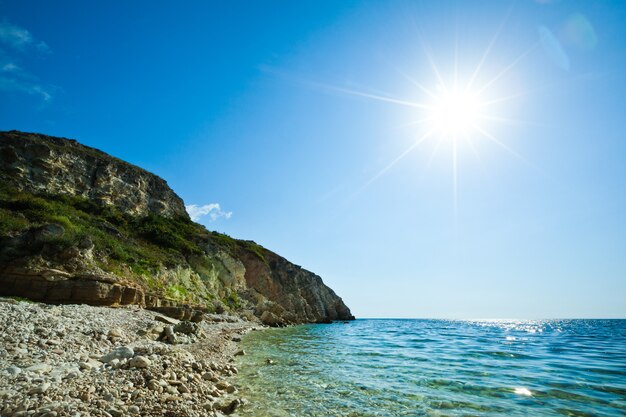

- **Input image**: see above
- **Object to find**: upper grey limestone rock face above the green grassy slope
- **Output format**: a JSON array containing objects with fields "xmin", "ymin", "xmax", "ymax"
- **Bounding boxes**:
[{"xmin": 0, "ymin": 131, "xmax": 189, "ymax": 218}]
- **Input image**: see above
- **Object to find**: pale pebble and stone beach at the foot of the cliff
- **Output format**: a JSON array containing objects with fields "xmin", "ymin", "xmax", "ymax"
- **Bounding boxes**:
[{"xmin": 0, "ymin": 298, "xmax": 264, "ymax": 417}]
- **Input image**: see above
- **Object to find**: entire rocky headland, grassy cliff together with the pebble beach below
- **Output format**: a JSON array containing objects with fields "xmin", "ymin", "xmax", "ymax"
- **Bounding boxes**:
[{"xmin": 0, "ymin": 131, "xmax": 354, "ymax": 417}]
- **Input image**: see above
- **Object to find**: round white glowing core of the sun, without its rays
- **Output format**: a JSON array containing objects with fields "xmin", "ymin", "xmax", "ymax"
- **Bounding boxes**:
[{"xmin": 429, "ymin": 91, "xmax": 482, "ymax": 136}]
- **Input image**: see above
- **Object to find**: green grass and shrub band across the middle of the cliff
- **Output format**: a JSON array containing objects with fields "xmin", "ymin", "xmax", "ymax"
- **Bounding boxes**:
[{"xmin": 0, "ymin": 184, "xmax": 267, "ymax": 284}]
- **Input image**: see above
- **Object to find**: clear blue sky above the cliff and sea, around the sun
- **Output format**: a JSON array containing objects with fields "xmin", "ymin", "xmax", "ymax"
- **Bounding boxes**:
[{"xmin": 0, "ymin": 0, "xmax": 626, "ymax": 318}]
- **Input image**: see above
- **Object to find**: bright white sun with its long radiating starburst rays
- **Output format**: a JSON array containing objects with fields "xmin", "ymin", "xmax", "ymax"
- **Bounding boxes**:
[{"xmin": 323, "ymin": 22, "xmax": 535, "ymax": 206}]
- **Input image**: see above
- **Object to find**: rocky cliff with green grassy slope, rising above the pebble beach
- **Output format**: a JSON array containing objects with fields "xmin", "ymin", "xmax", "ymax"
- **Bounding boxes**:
[{"xmin": 0, "ymin": 131, "xmax": 353, "ymax": 325}]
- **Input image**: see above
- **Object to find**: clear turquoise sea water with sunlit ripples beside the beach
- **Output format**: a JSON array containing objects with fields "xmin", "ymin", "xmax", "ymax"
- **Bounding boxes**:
[{"xmin": 236, "ymin": 320, "xmax": 626, "ymax": 417}]
